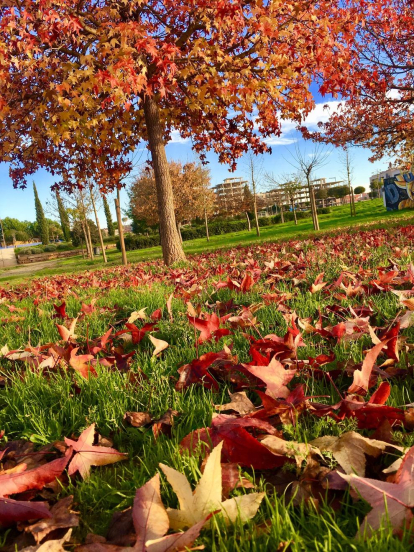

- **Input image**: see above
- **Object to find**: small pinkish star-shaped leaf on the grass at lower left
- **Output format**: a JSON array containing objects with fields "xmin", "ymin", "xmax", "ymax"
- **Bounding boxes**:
[{"xmin": 65, "ymin": 424, "xmax": 128, "ymax": 479}]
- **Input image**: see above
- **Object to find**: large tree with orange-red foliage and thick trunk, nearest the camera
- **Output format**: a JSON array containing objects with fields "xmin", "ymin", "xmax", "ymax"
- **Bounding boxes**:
[{"xmin": 0, "ymin": 0, "xmax": 352, "ymax": 264}]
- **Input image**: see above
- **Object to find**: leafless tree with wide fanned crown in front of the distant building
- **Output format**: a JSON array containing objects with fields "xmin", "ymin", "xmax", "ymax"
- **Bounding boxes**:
[{"xmin": 287, "ymin": 144, "xmax": 330, "ymax": 230}]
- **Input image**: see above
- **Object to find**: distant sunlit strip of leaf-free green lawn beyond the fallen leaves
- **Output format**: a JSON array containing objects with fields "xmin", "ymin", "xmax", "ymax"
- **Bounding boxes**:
[{"xmin": 0, "ymin": 199, "xmax": 414, "ymax": 284}]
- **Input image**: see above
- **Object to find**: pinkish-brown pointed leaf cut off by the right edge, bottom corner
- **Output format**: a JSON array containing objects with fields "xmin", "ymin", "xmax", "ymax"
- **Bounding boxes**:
[{"xmin": 339, "ymin": 447, "xmax": 414, "ymax": 535}]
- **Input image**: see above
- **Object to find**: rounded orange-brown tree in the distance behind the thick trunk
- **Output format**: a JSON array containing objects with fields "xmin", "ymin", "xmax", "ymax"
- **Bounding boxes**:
[{"xmin": 129, "ymin": 161, "xmax": 213, "ymax": 237}]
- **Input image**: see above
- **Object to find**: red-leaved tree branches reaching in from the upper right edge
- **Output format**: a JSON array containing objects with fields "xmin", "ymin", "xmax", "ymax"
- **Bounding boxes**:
[{"xmin": 305, "ymin": 0, "xmax": 414, "ymax": 166}]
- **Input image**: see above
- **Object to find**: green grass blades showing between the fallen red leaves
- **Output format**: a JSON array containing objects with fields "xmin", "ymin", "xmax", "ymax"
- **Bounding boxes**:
[{"xmin": 0, "ymin": 222, "xmax": 414, "ymax": 552}]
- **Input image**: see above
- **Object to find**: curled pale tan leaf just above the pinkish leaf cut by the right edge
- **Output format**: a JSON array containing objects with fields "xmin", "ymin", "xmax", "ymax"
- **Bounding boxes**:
[{"xmin": 311, "ymin": 431, "xmax": 402, "ymax": 477}]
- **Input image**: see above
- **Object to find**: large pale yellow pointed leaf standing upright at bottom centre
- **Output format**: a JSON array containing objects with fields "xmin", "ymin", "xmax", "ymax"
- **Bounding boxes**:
[{"xmin": 160, "ymin": 442, "xmax": 265, "ymax": 530}]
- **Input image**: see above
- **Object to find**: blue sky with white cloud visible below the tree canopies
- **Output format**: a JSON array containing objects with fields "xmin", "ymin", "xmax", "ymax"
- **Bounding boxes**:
[{"xmin": 0, "ymin": 98, "xmax": 389, "ymax": 226}]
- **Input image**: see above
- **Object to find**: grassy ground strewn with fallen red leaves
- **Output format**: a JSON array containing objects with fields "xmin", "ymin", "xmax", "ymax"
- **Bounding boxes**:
[{"xmin": 0, "ymin": 222, "xmax": 414, "ymax": 552}]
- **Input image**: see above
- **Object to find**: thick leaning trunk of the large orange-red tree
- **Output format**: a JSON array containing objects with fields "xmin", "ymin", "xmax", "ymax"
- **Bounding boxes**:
[{"xmin": 144, "ymin": 96, "xmax": 185, "ymax": 265}]
